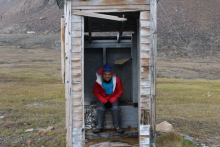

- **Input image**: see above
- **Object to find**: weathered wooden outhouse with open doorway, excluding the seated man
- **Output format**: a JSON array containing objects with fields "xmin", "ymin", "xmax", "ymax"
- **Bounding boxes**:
[{"xmin": 57, "ymin": 0, "xmax": 157, "ymax": 147}]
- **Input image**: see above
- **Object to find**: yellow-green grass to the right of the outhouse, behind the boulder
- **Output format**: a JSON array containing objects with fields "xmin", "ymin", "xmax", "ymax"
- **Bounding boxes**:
[{"xmin": 157, "ymin": 78, "xmax": 220, "ymax": 144}]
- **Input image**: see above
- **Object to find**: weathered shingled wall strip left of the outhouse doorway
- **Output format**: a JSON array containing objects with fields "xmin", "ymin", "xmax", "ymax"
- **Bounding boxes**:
[{"xmin": 71, "ymin": 15, "xmax": 85, "ymax": 147}]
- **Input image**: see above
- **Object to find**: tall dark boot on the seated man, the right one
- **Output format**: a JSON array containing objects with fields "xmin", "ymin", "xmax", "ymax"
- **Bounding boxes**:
[{"xmin": 111, "ymin": 109, "xmax": 124, "ymax": 133}]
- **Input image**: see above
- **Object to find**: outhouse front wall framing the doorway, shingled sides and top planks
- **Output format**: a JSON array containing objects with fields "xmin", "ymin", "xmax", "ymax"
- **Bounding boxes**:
[{"xmin": 64, "ymin": 0, "xmax": 157, "ymax": 147}]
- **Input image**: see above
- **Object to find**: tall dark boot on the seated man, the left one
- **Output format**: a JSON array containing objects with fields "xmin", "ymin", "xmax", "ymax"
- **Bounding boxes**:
[{"xmin": 93, "ymin": 109, "xmax": 105, "ymax": 133}]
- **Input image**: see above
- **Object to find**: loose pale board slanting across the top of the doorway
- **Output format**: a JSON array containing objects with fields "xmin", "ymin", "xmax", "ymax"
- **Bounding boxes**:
[{"xmin": 72, "ymin": 11, "xmax": 127, "ymax": 21}]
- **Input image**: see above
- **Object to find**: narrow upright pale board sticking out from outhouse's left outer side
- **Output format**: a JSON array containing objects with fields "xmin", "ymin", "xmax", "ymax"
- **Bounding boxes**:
[{"xmin": 61, "ymin": 17, "xmax": 65, "ymax": 83}]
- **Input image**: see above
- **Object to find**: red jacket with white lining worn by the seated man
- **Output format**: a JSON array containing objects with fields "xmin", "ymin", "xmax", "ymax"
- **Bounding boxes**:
[{"xmin": 93, "ymin": 69, "xmax": 123, "ymax": 104}]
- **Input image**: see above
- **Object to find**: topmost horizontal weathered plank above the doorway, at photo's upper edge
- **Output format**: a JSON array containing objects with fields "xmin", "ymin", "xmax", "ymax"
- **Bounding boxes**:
[{"xmin": 72, "ymin": 0, "xmax": 150, "ymax": 6}]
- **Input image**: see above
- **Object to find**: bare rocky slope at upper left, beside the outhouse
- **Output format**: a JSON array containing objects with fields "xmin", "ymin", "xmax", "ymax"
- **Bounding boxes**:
[{"xmin": 0, "ymin": 0, "xmax": 63, "ymax": 34}]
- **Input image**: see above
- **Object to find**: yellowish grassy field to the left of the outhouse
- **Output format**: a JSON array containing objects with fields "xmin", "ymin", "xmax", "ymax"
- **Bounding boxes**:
[{"xmin": 0, "ymin": 46, "xmax": 66, "ymax": 147}]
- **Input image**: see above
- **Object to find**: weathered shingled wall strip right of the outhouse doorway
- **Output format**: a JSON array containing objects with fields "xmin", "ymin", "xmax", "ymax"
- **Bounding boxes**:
[{"xmin": 139, "ymin": 11, "xmax": 151, "ymax": 147}]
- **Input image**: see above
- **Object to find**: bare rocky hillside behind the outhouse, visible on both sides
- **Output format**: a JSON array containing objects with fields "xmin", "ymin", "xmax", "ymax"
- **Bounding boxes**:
[{"xmin": 0, "ymin": 0, "xmax": 220, "ymax": 56}]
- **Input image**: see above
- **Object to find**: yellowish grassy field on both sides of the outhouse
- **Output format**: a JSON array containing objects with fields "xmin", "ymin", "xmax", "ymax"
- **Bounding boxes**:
[{"xmin": 0, "ymin": 48, "xmax": 220, "ymax": 147}]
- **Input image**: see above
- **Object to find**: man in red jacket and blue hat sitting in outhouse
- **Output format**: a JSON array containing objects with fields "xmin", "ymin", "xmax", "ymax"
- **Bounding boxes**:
[{"xmin": 93, "ymin": 64, "xmax": 124, "ymax": 133}]
